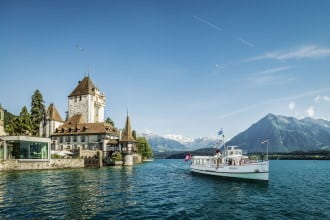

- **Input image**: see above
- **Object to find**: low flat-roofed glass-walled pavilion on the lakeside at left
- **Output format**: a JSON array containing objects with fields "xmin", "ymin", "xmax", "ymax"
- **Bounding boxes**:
[{"xmin": 0, "ymin": 136, "xmax": 50, "ymax": 160}]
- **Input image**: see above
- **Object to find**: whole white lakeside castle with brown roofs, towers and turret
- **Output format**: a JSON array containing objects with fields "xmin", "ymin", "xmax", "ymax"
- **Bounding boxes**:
[{"xmin": 40, "ymin": 76, "xmax": 136, "ymax": 157}]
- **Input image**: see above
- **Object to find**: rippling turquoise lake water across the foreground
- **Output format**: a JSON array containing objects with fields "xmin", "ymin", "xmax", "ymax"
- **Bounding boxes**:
[{"xmin": 0, "ymin": 160, "xmax": 330, "ymax": 219}]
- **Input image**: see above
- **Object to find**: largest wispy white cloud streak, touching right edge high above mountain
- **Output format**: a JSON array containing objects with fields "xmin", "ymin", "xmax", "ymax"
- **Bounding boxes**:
[{"xmin": 246, "ymin": 45, "xmax": 330, "ymax": 62}]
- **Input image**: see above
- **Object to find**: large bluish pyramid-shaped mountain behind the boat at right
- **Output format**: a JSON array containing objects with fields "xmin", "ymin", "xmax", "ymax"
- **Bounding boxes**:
[{"xmin": 227, "ymin": 113, "xmax": 330, "ymax": 152}]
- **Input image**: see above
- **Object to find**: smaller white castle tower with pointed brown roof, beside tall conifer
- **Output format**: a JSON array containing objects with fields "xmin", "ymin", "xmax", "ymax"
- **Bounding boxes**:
[{"xmin": 39, "ymin": 103, "xmax": 64, "ymax": 137}]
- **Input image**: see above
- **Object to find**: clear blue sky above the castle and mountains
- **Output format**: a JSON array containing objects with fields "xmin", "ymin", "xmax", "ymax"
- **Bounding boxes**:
[{"xmin": 0, "ymin": 0, "xmax": 330, "ymax": 138}]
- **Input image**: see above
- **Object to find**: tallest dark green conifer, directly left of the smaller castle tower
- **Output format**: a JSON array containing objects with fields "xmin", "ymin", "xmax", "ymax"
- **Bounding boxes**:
[{"xmin": 31, "ymin": 89, "xmax": 46, "ymax": 136}]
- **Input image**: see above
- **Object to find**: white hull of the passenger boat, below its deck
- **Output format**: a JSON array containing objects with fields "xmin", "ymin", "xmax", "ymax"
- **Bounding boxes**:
[{"xmin": 190, "ymin": 161, "xmax": 269, "ymax": 181}]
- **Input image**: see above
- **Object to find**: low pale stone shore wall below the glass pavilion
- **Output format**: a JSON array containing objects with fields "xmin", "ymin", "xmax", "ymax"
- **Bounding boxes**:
[{"xmin": 0, "ymin": 159, "xmax": 85, "ymax": 171}]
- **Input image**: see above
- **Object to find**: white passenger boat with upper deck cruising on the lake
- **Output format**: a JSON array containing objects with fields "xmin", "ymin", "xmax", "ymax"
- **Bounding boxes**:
[{"xmin": 190, "ymin": 146, "xmax": 269, "ymax": 181}]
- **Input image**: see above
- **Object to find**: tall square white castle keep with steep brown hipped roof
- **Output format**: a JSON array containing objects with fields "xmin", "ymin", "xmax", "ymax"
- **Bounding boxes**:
[{"xmin": 68, "ymin": 76, "xmax": 105, "ymax": 123}]
